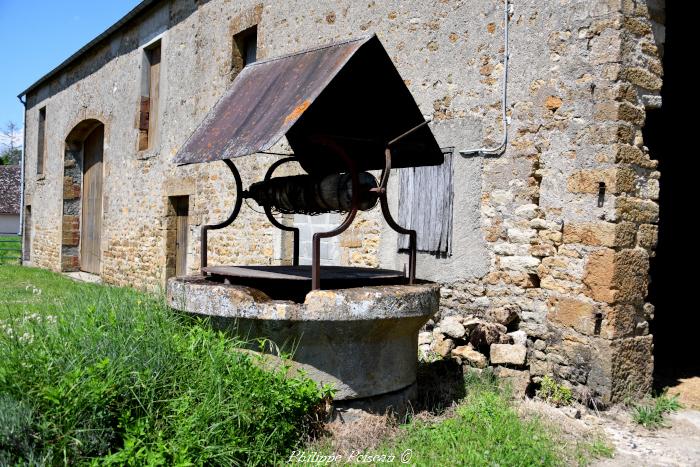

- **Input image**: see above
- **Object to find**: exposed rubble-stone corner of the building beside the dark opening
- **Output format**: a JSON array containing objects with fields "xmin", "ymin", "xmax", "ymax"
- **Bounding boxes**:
[{"xmin": 424, "ymin": 2, "xmax": 662, "ymax": 403}]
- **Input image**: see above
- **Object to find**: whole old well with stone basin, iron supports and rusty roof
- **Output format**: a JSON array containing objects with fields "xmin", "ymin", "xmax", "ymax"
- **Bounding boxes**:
[{"xmin": 168, "ymin": 35, "xmax": 445, "ymax": 413}]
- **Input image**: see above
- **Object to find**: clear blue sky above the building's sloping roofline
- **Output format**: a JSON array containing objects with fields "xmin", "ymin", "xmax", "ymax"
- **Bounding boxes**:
[{"xmin": 0, "ymin": 0, "xmax": 139, "ymax": 144}]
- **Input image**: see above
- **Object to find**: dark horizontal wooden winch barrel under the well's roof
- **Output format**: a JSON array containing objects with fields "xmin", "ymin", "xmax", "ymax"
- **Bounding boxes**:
[{"xmin": 248, "ymin": 172, "xmax": 378, "ymax": 214}]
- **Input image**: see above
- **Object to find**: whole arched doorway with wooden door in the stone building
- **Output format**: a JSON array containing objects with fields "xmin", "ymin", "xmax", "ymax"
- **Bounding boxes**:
[{"xmin": 61, "ymin": 119, "xmax": 104, "ymax": 274}]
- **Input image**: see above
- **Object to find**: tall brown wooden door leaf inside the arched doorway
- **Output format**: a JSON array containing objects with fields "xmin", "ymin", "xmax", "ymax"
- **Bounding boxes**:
[{"xmin": 80, "ymin": 125, "xmax": 104, "ymax": 274}]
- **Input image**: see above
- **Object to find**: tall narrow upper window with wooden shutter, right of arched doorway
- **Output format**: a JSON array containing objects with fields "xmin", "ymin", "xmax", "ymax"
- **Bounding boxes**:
[{"xmin": 138, "ymin": 41, "xmax": 161, "ymax": 151}]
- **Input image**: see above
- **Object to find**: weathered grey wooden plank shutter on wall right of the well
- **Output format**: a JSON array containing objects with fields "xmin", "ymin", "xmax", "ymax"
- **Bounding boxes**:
[{"xmin": 399, "ymin": 149, "xmax": 454, "ymax": 256}]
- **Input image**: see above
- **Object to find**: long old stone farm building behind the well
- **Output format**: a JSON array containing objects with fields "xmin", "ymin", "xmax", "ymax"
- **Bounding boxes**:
[{"xmin": 21, "ymin": 0, "xmax": 680, "ymax": 402}]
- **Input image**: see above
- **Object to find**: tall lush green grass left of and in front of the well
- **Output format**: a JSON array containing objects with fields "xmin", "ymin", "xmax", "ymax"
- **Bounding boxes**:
[{"xmin": 0, "ymin": 266, "xmax": 324, "ymax": 465}]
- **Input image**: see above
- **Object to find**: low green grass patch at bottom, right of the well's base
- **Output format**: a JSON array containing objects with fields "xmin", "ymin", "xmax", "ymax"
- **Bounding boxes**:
[{"xmin": 300, "ymin": 371, "xmax": 613, "ymax": 466}]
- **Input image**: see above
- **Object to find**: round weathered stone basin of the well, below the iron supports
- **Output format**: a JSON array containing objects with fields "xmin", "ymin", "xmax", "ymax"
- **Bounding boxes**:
[{"xmin": 168, "ymin": 276, "xmax": 439, "ymax": 412}]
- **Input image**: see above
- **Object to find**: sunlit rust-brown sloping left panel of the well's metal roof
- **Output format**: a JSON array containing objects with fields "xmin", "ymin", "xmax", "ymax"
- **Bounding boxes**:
[{"xmin": 175, "ymin": 38, "xmax": 369, "ymax": 164}]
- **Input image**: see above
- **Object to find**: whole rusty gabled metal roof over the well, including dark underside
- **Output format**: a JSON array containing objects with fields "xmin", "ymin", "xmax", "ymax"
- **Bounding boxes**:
[{"xmin": 175, "ymin": 35, "xmax": 443, "ymax": 172}]
